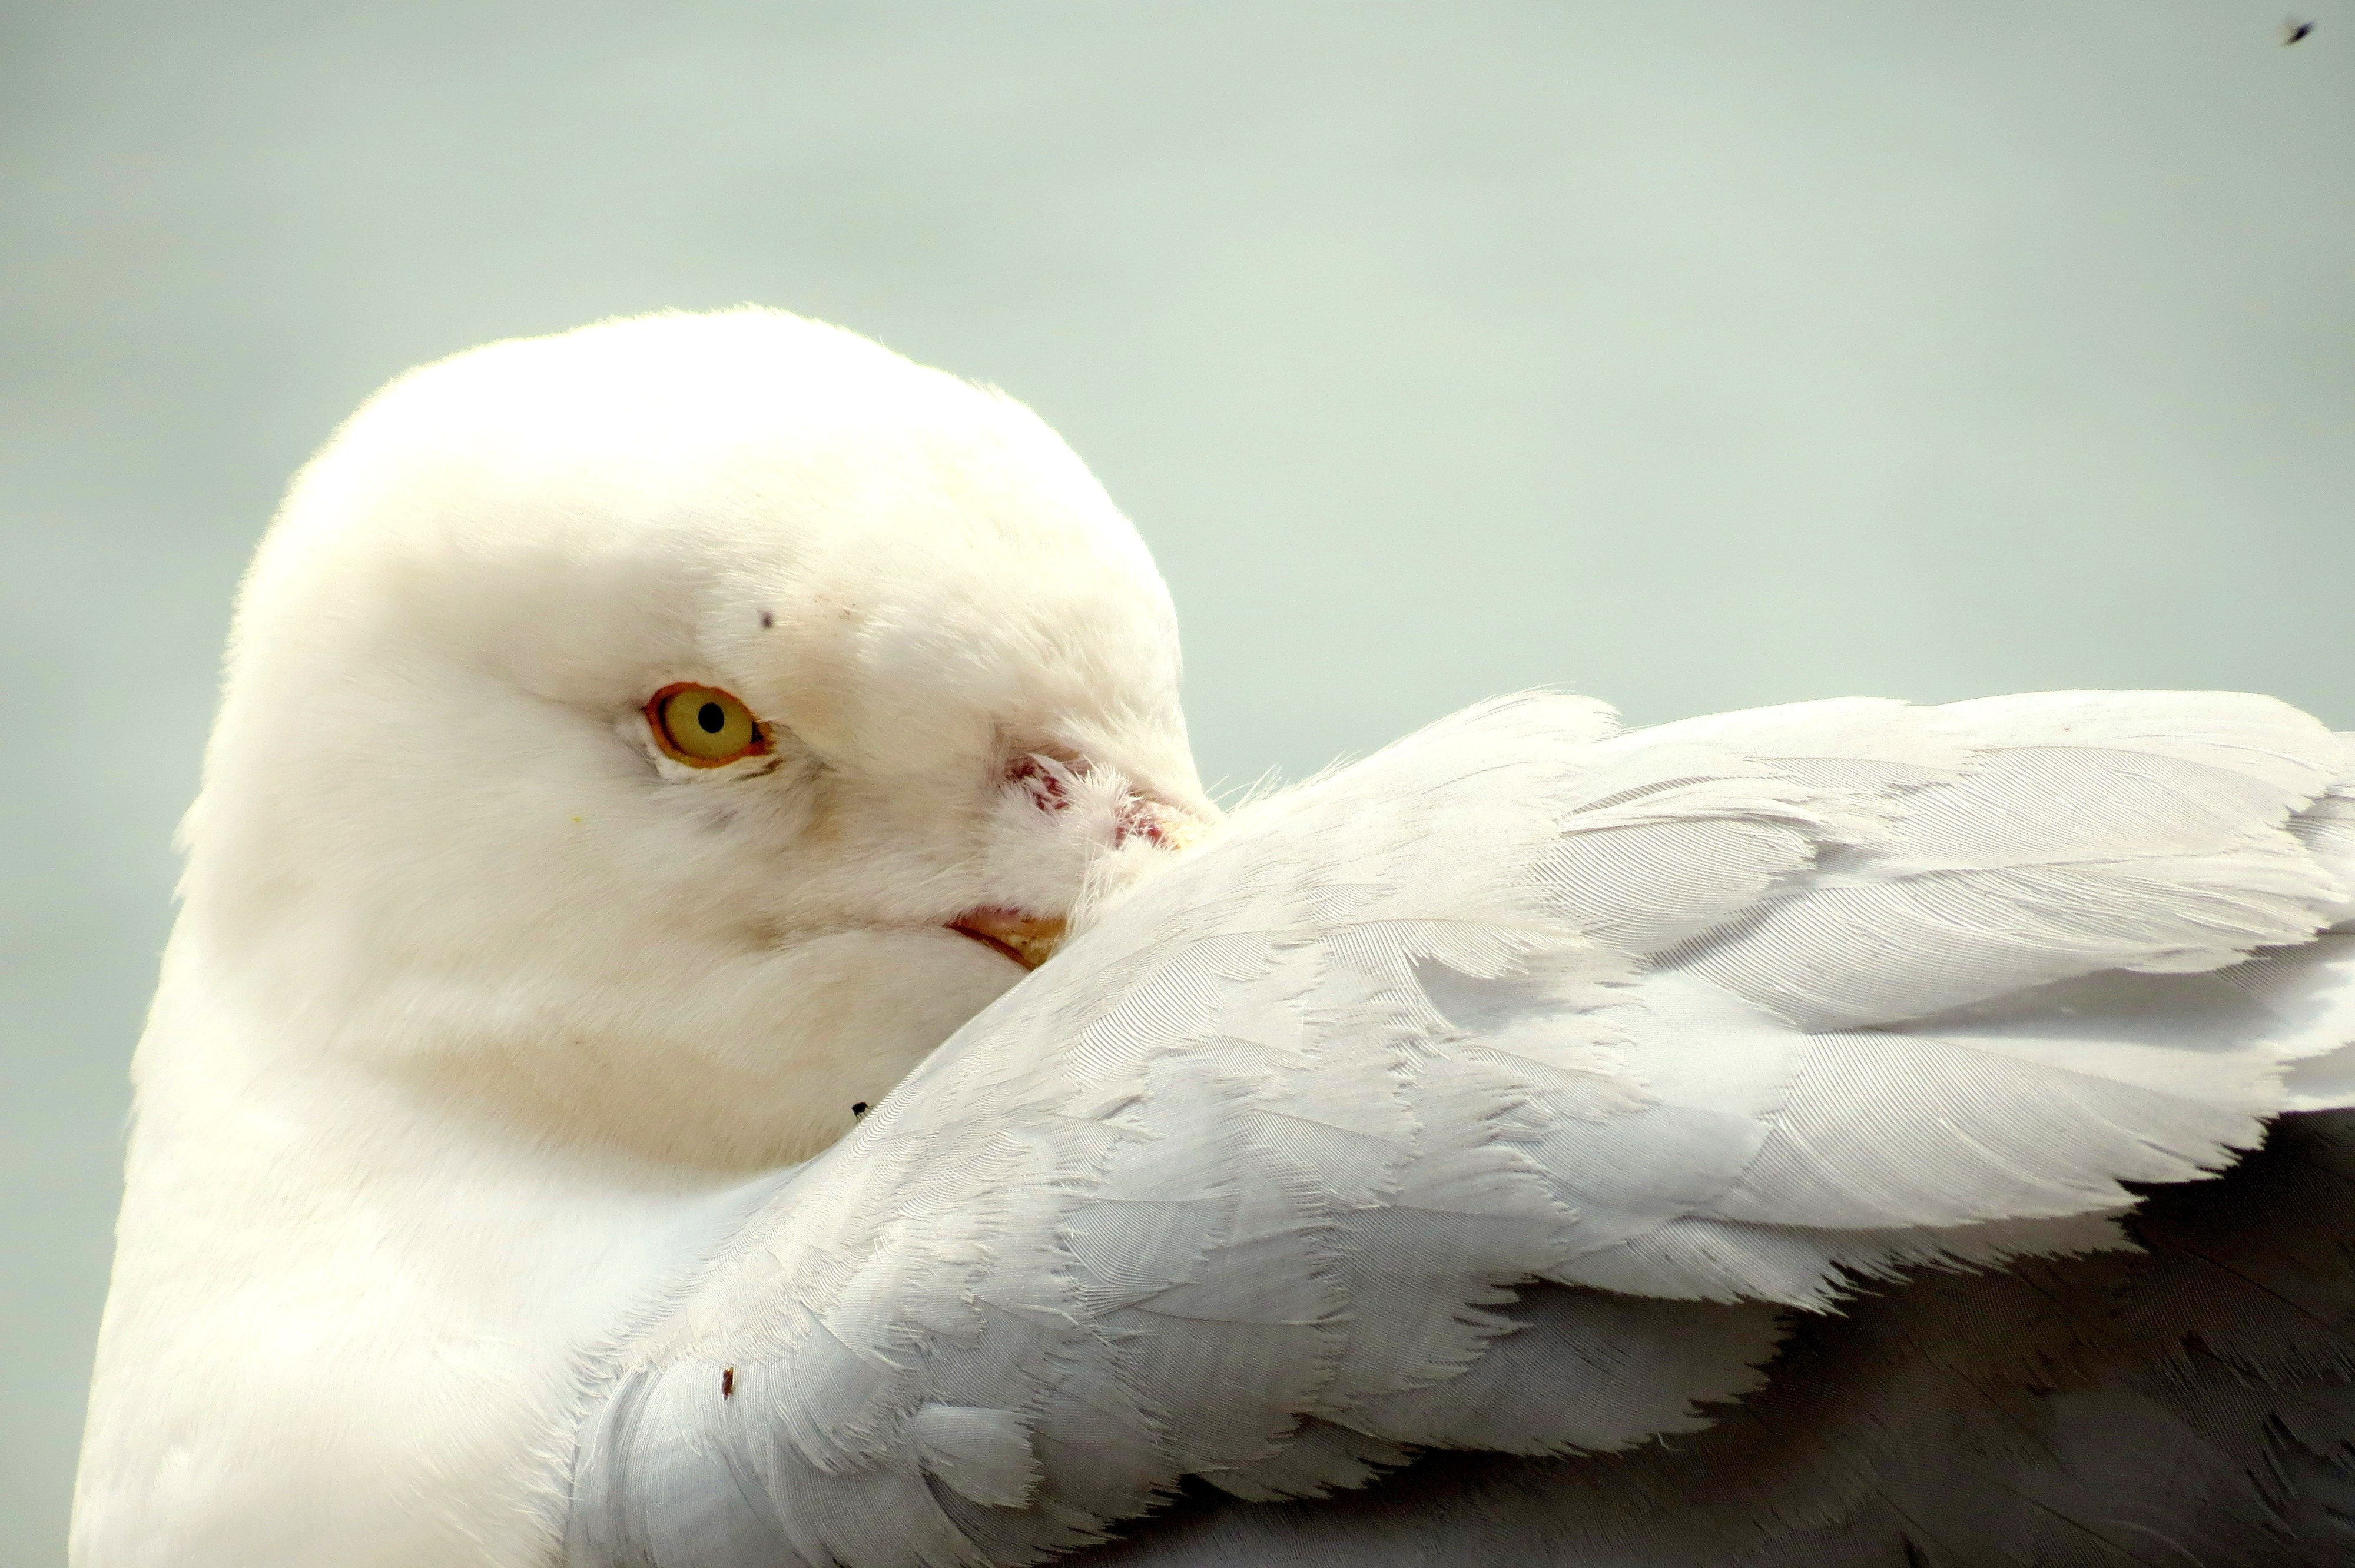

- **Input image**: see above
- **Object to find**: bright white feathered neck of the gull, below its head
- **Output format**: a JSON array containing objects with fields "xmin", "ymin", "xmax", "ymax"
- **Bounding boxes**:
[{"xmin": 75, "ymin": 923, "xmax": 751, "ymax": 1568}]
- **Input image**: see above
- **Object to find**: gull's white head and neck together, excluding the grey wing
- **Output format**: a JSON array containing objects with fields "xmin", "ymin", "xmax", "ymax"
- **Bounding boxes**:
[{"xmin": 78, "ymin": 308, "xmax": 1215, "ymax": 1566}]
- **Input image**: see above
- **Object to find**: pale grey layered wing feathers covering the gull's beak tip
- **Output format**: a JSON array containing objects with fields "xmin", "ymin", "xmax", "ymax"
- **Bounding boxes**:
[{"xmin": 568, "ymin": 695, "xmax": 2355, "ymax": 1568}]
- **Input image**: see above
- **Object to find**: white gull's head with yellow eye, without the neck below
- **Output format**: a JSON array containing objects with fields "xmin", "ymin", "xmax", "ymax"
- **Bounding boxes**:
[{"xmin": 167, "ymin": 311, "xmax": 1215, "ymax": 1170}]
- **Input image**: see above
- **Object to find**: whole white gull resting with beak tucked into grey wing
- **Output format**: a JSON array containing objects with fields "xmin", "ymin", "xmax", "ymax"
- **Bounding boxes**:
[{"xmin": 73, "ymin": 311, "xmax": 2355, "ymax": 1568}]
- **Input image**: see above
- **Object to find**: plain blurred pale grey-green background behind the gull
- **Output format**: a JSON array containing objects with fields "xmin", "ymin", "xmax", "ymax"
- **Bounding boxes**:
[{"xmin": 0, "ymin": 0, "xmax": 2355, "ymax": 1568}]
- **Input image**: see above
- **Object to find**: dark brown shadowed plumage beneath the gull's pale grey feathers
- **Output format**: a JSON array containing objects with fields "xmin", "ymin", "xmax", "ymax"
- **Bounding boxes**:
[{"xmin": 1069, "ymin": 1111, "xmax": 2355, "ymax": 1568}]
